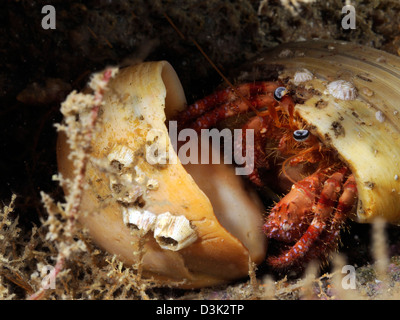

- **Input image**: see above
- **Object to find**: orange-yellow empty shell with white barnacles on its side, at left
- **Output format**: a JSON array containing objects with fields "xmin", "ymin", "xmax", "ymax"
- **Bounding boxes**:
[{"xmin": 57, "ymin": 61, "xmax": 266, "ymax": 288}]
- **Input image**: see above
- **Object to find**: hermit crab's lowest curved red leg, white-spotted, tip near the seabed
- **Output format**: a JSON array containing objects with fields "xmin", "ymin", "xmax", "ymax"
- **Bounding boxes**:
[{"xmin": 268, "ymin": 168, "xmax": 347, "ymax": 269}]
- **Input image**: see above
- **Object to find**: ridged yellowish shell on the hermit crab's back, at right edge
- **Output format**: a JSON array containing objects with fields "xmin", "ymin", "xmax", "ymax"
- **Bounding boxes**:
[{"xmin": 259, "ymin": 41, "xmax": 400, "ymax": 224}]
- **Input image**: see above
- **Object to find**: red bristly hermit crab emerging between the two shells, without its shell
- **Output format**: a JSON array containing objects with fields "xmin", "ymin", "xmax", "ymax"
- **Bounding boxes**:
[{"xmin": 178, "ymin": 75, "xmax": 357, "ymax": 268}]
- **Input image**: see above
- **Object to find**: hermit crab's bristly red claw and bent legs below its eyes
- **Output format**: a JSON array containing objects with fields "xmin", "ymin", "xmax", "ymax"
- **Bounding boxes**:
[{"xmin": 264, "ymin": 167, "xmax": 357, "ymax": 269}]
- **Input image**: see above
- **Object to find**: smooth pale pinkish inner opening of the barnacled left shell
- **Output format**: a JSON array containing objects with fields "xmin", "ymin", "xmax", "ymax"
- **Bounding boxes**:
[{"xmin": 184, "ymin": 138, "xmax": 266, "ymax": 260}]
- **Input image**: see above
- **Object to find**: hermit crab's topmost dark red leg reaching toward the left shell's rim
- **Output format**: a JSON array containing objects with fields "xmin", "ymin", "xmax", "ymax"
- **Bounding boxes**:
[{"xmin": 176, "ymin": 81, "xmax": 278, "ymax": 127}]
